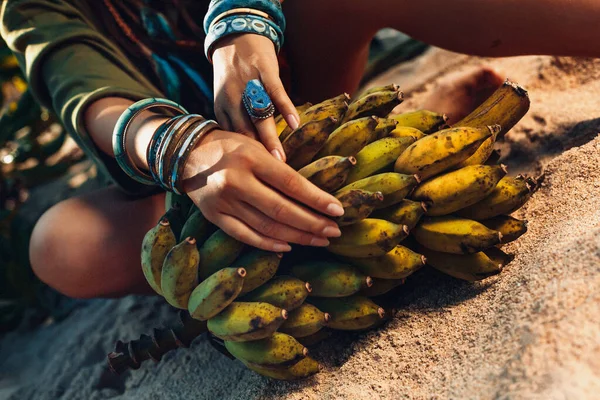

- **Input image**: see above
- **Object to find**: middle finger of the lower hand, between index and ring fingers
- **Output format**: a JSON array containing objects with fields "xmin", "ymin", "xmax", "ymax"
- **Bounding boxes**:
[{"xmin": 239, "ymin": 177, "xmax": 341, "ymax": 237}]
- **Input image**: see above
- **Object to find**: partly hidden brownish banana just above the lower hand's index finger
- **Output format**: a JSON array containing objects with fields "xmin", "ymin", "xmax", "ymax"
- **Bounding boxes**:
[{"xmin": 298, "ymin": 156, "xmax": 356, "ymax": 192}]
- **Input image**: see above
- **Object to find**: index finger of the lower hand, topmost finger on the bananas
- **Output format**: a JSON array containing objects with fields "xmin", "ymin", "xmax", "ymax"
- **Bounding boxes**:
[{"xmin": 253, "ymin": 157, "xmax": 344, "ymax": 217}]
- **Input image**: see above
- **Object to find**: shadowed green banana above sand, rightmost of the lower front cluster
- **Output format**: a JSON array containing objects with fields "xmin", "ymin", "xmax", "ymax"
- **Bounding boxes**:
[{"xmin": 310, "ymin": 295, "xmax": 385, "ymax": 331}]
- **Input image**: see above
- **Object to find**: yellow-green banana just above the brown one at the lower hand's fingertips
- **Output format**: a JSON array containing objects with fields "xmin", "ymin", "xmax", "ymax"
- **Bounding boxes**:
[{"xmin": 336, "ymin": 172, "xmax": 420, "ymax": 209}]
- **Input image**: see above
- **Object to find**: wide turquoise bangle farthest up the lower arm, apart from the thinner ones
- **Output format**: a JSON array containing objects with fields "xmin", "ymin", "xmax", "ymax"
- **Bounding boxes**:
[{"xmin": 112, "ymin": 98, "xmax": 188, "ymax": 185}]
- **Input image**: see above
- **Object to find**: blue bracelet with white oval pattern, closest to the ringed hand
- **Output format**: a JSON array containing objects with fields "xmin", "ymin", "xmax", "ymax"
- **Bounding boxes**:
[{"xmin": 204, "ymin": 15, "xmax": 283, "ymax": 62}]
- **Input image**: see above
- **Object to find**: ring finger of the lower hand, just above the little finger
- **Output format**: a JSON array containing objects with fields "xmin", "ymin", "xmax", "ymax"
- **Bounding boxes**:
[{"xmin": 236, "ymin": 203, "xmax": 329, "ymax": 247}]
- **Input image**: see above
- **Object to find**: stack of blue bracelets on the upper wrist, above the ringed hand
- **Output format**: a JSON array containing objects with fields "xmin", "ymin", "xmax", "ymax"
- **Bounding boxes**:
[{"xmin": 204, "ymin": 0, "xmax": 285, "ymax": 62}]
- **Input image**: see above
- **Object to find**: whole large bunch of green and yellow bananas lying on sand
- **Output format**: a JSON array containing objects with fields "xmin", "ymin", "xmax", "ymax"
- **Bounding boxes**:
[{"xmin": 113, "ymin": 81, "xmax": 537, "ymax": 380}]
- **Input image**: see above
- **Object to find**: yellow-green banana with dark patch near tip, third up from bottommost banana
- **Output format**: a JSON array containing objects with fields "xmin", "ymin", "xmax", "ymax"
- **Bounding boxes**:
[{"xmin": 207, "ymin": 301, "xmax": 288, "ymax": 342}]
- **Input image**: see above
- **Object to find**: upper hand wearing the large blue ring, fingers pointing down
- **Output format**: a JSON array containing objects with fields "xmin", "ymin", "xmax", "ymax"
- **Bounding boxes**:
[{"xmin": 213, "ymin": 34, "xmax": 300, "ymax": 161}]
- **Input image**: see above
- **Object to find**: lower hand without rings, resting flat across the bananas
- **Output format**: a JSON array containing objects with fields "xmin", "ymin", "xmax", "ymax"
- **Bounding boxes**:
[{"xmin": 183, "ymin": 130, "xmax": 344, "ymax": 252}]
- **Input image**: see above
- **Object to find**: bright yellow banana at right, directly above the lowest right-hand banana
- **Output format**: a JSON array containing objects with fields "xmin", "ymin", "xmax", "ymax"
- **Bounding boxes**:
[{"xmin": 411, "ymin": 215, "xmax": 502, "ymax": 254}]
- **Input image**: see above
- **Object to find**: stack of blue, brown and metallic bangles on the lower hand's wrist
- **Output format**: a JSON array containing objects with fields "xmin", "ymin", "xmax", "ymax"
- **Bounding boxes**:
[{"xmin": 113, "ymin": 98, "xmax": 220, "ymax": 194}]
